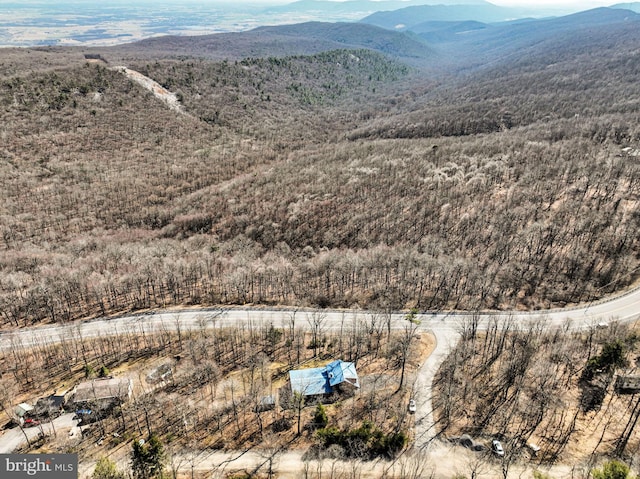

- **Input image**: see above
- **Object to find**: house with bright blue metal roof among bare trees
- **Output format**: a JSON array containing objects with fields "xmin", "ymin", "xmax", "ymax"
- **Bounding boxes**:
[{"xmin": 289, "ymin": 359, "xmax": 360, "ymax": 396}]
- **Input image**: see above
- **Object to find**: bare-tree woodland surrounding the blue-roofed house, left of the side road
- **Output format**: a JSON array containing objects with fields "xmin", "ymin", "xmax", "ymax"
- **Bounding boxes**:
[{"xmin": 0, "ymin": 312, "xmax": 429, "ymax": 462}]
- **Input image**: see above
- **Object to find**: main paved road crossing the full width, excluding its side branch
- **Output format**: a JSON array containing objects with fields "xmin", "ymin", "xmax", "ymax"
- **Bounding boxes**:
[{"xmin": 5, "ymin": 282, "xmax": 640, "ymax": 350}]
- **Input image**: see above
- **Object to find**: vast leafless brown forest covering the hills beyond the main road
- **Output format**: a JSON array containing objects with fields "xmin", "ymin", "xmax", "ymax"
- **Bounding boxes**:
[{"xmin": 0, "ymin": 27, "xmax": 640, "ymax": 327}]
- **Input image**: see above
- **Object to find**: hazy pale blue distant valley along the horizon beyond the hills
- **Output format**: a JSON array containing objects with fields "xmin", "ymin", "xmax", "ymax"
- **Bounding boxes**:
[{"xmin": 0, "ymin": 0, "xmax": 608, "ymax": 47}]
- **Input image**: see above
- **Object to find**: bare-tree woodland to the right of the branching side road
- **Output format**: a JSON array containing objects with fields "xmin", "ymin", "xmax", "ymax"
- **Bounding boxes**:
[{"xmin": 434, "ymin": 317, "xmax": 640, "ymax": 467}]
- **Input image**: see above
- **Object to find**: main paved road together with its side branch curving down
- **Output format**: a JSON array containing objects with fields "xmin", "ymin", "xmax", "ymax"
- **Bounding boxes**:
[{"xmin": 0, "ymin": 288, "xmax": 640, "ymax": 456}]
